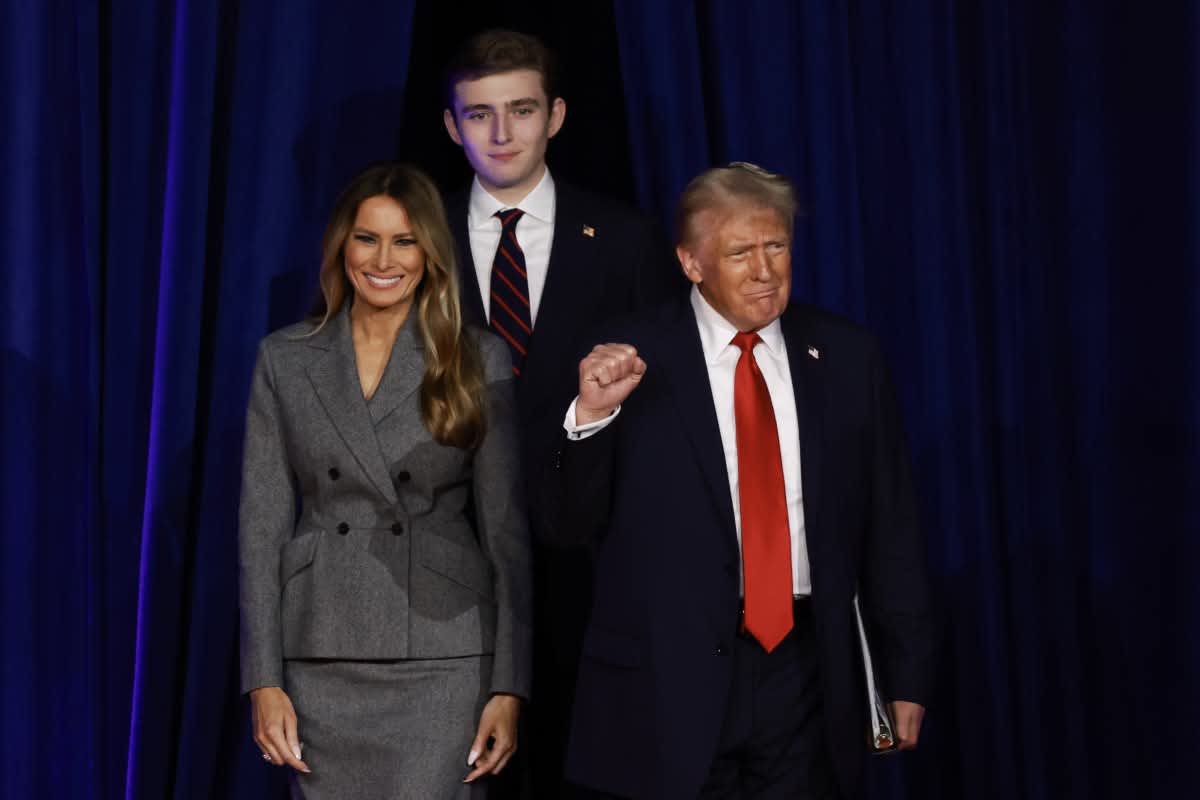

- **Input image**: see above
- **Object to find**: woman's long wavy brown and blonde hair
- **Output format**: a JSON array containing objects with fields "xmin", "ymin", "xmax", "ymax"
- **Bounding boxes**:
[{"xmin": 312, "ymin": 162, "xmax": 486, "ymax": 449}]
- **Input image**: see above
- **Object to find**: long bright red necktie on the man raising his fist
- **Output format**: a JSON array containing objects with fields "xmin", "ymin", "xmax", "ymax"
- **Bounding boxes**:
[{"xmin": 733, "ymin": 333, "xmax": 792, "ymax": 652}]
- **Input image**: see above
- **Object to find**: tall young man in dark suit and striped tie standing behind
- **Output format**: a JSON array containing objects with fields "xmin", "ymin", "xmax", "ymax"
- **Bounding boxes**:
[{"xmin": 444, "ymin": 30, "xmax": 682, "ymax": 798}]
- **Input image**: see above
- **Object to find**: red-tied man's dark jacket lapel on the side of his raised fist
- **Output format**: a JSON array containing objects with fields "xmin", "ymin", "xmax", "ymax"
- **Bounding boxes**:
[{"xmin": 648, "ymin": 295, "xmax": 737, "ymax": 558}]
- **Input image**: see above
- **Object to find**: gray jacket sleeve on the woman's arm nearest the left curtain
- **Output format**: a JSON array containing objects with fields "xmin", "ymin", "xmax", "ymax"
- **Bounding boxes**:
[{"xmin": 238, "ymin": 342, "xmax": 296, "ymax": 692}]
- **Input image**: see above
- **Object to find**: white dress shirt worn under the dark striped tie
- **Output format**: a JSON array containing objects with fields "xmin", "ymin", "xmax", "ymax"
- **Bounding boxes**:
[{"xmin": 467, "ymin": 169, "xmax": 554, "ymax": 324}]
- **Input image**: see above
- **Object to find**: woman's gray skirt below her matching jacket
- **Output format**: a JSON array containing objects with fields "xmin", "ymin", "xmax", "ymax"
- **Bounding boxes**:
[{"xmin": 284, "ymin": 656, "xmax": 492, "ymax": 800}]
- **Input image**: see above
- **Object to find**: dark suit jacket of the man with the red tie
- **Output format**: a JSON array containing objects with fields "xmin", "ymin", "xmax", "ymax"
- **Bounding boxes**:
[{"xmin": 545, "ymin": 296, "xmax": 932, "ymax": 800}]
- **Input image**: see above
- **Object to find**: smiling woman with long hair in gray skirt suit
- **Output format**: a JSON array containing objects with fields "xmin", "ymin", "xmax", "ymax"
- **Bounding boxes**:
[{"xmin": 239, "ymin": 163, "xmax": 530, "ymax": 800}]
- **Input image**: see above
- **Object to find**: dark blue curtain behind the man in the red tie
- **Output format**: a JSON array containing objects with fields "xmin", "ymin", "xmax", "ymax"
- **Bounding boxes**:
[{"xmin": 616, "ymin": 0, "xmax": 1200, "ymax": 800}]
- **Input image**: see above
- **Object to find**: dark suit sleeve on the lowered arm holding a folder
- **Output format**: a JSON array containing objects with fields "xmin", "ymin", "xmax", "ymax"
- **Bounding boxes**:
[{"xmin": 862, "ymin": 338, "xmax": 935, "ymax": 704}]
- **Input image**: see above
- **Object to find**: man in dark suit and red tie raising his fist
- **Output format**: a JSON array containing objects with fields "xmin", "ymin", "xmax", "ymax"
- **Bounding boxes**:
[{"xmin": 547, "ymin": 163, "xmax": 932, "ymax": 800}]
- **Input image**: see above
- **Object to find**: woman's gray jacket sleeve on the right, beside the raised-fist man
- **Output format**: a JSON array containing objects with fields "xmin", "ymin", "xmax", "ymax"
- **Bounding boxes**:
[{"xmin": 474, "ymin": 333, "xmax": 533, "ymax": 698}]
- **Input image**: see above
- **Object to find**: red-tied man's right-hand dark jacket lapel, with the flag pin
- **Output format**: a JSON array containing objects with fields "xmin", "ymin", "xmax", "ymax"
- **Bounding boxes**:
[{"xmin": 781, "ymin": 311, "xmax": 826, "ymax": 532}]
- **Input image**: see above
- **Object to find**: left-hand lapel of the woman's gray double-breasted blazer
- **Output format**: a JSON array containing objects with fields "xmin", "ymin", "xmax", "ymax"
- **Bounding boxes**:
[{"xmin": 307, "ymin": 309, "xmax": 396, "ymax": 503}]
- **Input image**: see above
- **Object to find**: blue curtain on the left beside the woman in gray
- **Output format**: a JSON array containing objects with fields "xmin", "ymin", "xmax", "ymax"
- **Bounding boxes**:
[{"xmin": 0, "ymin": 0, "xmax": 413, "ymax": 798}]
